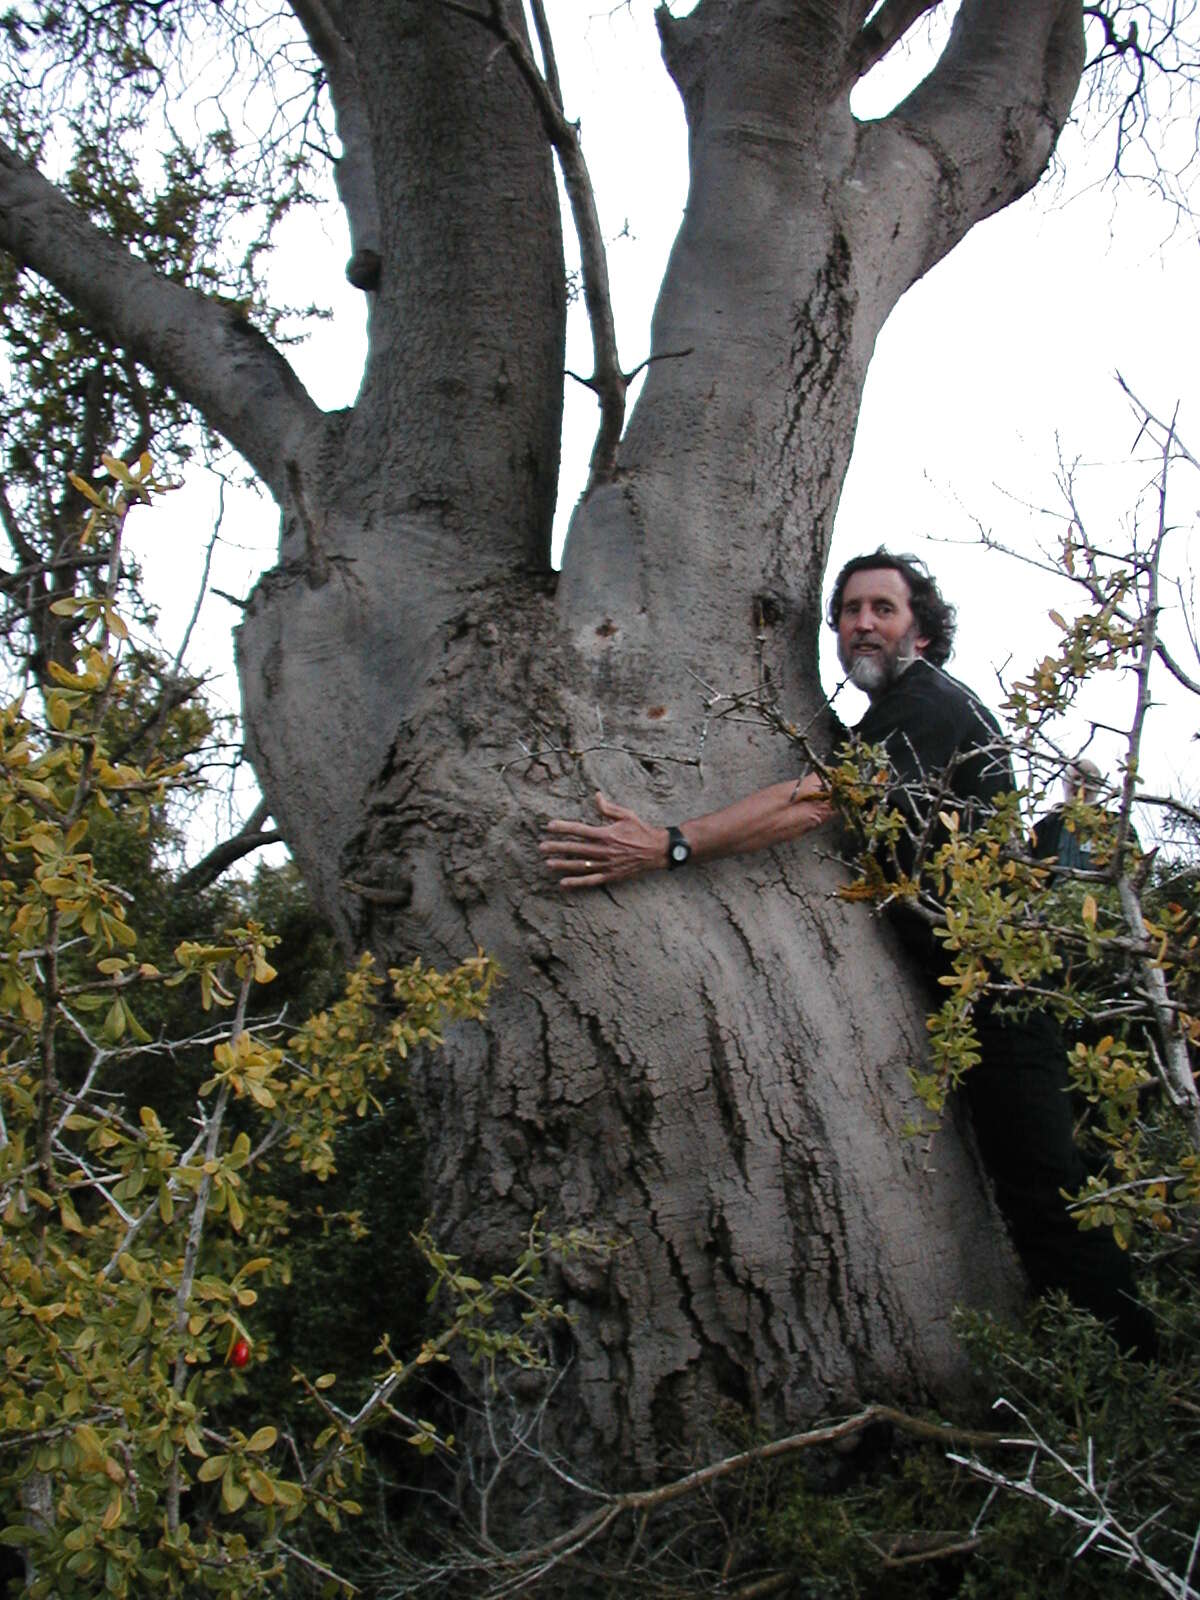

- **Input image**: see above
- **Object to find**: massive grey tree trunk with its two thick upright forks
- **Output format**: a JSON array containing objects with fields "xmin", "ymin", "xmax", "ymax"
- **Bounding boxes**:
[{"xmin": 0, "ymin": 0, "xmax": 1082, "ymax": 1470}]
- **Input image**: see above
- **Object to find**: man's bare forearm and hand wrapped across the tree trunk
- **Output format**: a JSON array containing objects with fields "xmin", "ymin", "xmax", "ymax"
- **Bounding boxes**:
[{"xmin": 539, "ymin": 773, "xmax": 834, "ymax": 890}]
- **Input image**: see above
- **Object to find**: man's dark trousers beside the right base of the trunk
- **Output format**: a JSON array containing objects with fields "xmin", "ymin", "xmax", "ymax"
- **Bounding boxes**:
[{"xmin": 963, "ymin": 1013, "xmax": 1155, "ymax": 1357}]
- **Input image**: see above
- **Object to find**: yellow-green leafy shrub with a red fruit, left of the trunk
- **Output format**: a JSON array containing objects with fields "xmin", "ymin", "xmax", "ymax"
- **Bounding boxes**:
[{"xmin": 0, "ymin": 458, "xmax": 496, "ymax": 1600}]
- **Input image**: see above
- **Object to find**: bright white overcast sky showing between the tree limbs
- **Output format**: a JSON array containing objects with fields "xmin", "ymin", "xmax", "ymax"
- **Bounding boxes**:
[{"xmin": 124, "ymin": 0, "xmax": 1200, "ymax": 848}]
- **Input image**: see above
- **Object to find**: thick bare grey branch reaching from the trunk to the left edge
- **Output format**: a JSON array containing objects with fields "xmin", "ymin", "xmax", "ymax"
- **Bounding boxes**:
[{"xmin": 0, "ymin": 144, "xmax": 322, "ymax": 498}]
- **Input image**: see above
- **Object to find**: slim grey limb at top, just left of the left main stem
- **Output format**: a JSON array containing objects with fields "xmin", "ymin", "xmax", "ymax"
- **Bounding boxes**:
[{"xmin": 290, "ymin": 0, "xmax": 379, "ymax": 290}]
